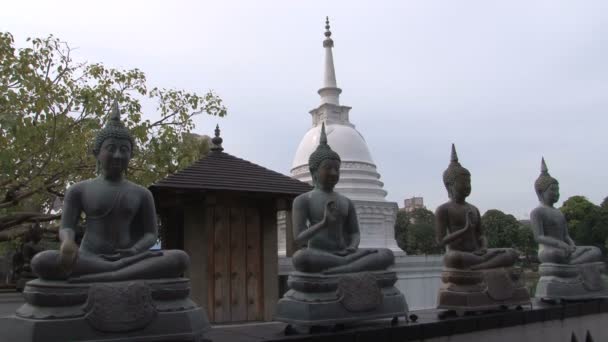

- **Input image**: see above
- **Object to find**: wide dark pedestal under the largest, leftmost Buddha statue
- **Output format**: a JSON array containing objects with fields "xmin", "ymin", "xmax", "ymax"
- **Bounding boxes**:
[{"xmin": 0, "ymin": 278, "xmax": 209, "ymax": 342}]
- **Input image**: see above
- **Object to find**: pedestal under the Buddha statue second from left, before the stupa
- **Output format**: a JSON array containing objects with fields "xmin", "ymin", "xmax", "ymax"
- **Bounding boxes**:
[{"xmin": 275, "ymin": 271, "xmax": 408, "ymax": 326}]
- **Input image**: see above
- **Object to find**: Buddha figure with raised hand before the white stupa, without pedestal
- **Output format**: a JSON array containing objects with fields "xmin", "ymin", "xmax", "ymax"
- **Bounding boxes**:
[{"xmin": 292, "ymin": 123, "xmax": 394, "ymax": 274}]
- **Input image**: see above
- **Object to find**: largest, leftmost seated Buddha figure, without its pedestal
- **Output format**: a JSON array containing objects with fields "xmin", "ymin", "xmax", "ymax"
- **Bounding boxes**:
[{"xmin": 31, "ymin": 103, "xmax": 189, "ymax": 282}]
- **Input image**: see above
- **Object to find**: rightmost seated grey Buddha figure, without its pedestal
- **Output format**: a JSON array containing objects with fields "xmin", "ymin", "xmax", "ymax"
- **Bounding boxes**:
[{"xmin": 530, "ymin": 158, "xmax": 602, "ymax": 265}]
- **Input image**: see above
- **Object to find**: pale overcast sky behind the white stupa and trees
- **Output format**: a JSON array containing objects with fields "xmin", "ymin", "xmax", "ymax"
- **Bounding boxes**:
[{"xmin": 0, "ymin": 0, "xmax": 608, "ymax": 218}]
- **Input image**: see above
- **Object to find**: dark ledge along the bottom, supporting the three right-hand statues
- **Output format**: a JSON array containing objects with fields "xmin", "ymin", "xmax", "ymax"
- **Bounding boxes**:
[{"xmin": 207, "ymin": 300, "xmax": 608, "ymax": 342}]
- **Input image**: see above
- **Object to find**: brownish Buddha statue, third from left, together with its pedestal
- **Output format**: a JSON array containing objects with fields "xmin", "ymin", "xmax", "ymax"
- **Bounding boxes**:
[{"xmin": 435, "ymin": 145, "xmax": 530, "ymax": 312}]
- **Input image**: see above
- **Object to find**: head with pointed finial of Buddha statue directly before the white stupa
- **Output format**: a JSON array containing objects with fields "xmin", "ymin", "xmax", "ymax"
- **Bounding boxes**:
[{"xmin": 308, "ymin": 123, "xmax": 341, "ymax": 191}]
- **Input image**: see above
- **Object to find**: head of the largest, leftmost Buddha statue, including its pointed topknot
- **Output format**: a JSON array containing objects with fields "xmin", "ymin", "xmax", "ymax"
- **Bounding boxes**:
[{"xmin": 93, "ymin": 102, "xmax": 135, "ymax": 178}]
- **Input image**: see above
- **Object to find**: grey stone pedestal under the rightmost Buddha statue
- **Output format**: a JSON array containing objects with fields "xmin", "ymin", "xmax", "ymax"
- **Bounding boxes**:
[{"xmin": 535, "ymin": 262, "xmax": 608, "ymax": 300}]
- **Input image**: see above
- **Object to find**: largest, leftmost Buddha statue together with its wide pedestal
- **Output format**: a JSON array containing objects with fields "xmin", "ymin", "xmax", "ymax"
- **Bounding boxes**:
[{"xmin": 0, "ymin": 103, "xmax": 209, "ymax": 342}]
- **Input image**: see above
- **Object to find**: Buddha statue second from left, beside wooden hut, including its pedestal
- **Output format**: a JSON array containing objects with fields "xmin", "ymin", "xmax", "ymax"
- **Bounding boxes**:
[{"xmin": 275, "ymin": 123, "xmax": 407, "ymax": 331}]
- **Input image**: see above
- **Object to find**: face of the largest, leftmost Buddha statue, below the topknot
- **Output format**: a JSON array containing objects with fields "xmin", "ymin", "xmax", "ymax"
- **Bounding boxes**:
[{"xmin": 95, "ymin": 137, "xmax": 132, "ymax": 178}]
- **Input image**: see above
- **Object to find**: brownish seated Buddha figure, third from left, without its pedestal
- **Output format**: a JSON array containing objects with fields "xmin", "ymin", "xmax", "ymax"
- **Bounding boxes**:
[{"xmin": 435, "ymin": 145, "xmax": 518, "ymax": 270}]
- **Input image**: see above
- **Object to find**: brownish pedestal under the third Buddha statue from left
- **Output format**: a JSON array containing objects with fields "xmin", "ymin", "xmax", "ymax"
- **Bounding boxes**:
[{"xmin": 437, "ymin": 268, "xmax": 530, "ymax": 312}]
